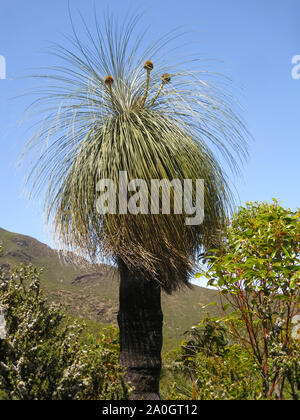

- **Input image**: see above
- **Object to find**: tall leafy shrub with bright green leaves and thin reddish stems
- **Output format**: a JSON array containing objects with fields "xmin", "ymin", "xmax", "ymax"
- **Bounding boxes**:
[{"xmin": 205, "ymin": 200, "xmax": 300, "ymax": 400}]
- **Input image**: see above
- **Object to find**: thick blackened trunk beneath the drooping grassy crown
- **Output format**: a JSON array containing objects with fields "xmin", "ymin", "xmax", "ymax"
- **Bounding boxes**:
[{"xmin": 118, "ymin": 262, "xmax": 163, "ymax": 400}]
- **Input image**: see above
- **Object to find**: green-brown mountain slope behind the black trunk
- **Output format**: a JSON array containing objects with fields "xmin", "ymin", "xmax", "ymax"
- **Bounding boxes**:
[{"xmin": 0, "ymin": 228, "xmax": 217, "ymax": 349}]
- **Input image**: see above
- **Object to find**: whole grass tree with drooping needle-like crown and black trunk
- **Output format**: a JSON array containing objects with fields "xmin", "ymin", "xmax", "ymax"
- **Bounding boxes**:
[{"xmin": 22, "ymin": 13, "xmax": 247, "ymax": 399}]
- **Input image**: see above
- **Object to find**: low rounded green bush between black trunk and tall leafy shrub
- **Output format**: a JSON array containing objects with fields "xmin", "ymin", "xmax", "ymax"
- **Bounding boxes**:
[{"xmin": 162, "ymin": 321, "xmax": 263, "ymax": 400}]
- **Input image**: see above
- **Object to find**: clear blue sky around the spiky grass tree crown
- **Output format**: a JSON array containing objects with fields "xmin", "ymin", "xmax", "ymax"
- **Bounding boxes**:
[{"xmin": 0, "ymin": 0, "xmax": 300, "ymax": 249}]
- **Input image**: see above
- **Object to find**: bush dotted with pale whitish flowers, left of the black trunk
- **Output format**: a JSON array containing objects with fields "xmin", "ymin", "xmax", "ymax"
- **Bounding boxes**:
[{"xmin": 0, "ymin": 266, "xmax": 127, "ymax": 400}]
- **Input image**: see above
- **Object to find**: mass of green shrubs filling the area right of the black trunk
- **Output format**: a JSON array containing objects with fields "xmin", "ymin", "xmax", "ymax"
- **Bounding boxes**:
[{"xmin": 163, "ymin": 200, "xmax": 300, "ymax": 400}]
